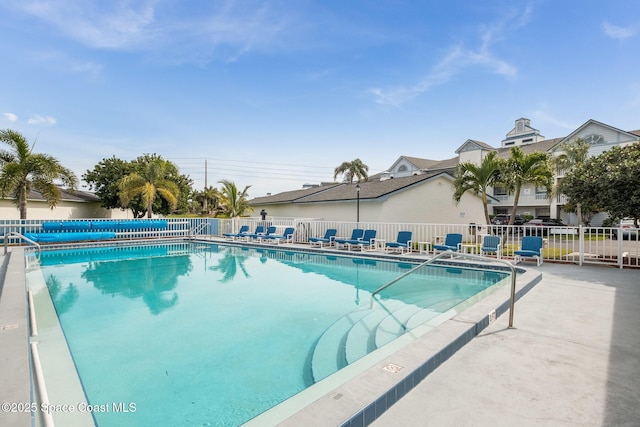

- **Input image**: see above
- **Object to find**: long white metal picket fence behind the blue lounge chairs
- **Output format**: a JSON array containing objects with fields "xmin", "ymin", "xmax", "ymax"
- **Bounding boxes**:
[{"xmin": 0, "ymin": 217, "xmax": 640, "ymax": 268}]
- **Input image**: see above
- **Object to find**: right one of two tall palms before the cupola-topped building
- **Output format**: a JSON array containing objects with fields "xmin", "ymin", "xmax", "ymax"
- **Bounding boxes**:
[{"xmin": 499, "ymin": 147, "xmax": 553, "ymax": 225}]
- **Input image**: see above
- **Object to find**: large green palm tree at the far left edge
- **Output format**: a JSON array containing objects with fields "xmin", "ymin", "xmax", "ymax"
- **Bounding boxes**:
[{"xmin": 0, "ymin": 129, "xmax": 78, "ymax": 219}]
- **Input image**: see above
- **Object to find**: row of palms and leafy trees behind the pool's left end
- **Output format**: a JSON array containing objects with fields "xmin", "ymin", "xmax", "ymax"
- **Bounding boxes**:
[{"xmin": 0, "ymin": 129, "xmax": 252, "ymax": 219}]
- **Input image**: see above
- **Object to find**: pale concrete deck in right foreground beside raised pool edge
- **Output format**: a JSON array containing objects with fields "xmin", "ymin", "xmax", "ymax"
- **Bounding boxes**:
[{"xmin": 371, "ymin": 263, "xmax": 640, "ymax": 427}]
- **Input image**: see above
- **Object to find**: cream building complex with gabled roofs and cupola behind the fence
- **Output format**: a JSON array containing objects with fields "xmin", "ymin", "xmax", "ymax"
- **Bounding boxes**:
[{"xmin": 251, "ymin": 117, "xmax": 640, "ymax": 225}]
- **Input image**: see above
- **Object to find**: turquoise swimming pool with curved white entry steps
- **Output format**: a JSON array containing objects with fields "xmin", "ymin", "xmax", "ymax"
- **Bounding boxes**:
[{"xmin": 27, "ymin": 243, "xmax": 505, "ymax": 426}]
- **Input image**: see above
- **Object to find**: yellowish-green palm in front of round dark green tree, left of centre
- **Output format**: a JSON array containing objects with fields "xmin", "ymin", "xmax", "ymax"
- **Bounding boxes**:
[{"xmin": 118, "ymin": 158, "xmax": 180, "ymax": 218}]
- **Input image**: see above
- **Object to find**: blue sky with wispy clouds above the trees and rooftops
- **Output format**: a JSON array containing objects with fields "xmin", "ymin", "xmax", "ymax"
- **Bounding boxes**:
[{"xmin": 0, "ymin": 0, "xmax": 640, "ymax": 197}]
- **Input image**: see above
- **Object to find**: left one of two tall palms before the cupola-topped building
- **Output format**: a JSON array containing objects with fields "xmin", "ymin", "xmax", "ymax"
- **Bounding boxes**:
[{"xmin": 453, "ymin": 151, "xmax": 504, "ymax": 225}]
